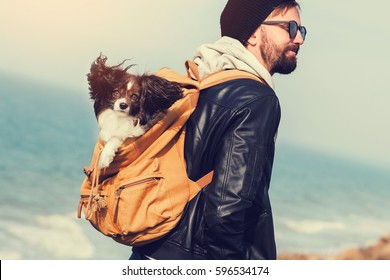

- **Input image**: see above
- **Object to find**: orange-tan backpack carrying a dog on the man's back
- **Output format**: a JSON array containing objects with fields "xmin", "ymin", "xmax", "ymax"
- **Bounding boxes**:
[{"xmin": 78, "ymin": 61, "xmax": 259, "ymax": 246}]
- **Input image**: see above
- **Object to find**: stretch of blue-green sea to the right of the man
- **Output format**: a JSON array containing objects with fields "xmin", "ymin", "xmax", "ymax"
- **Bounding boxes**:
[{"xmin": 270, "ymin": 146, "xmax": 390, "ymax": 257}]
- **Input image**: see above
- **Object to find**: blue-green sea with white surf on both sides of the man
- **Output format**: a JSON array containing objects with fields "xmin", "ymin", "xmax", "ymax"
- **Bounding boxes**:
[{"xmin": 0, "ymin": 73, "xmax": 390, "ymax": 260}]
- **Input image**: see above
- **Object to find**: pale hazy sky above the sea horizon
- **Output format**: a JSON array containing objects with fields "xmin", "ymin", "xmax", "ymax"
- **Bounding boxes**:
[{"xmin": 0, "ymin": 0, "xmax": 390, "ymax": 168}]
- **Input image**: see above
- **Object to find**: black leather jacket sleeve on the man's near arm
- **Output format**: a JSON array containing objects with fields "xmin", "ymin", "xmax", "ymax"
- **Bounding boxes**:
[{"xmin": 204, "ymin": 95, "xmax": 280, "ymax": 259}]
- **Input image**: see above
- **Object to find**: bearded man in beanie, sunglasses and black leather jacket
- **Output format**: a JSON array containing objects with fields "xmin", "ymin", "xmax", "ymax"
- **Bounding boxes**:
[{"xmin": 132, "ymin": 0, "xmax": 306, "ymax": 259}]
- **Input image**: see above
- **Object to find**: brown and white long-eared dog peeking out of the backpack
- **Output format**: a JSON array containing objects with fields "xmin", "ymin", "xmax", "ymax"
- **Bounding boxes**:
[{"xmin": 87, "ymin": 55, "xmax": 183, "ymax": 169}]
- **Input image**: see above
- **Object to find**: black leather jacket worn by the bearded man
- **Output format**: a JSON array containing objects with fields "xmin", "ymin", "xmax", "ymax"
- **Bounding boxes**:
[{"xmin": 135, "ymin": 79, "xmax": 280, "ymax": 259}]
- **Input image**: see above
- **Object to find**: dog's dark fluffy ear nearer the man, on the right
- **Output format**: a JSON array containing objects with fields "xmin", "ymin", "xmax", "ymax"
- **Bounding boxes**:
[{"xmin": 140, "ymin": 75, "xmax": 183, "ymax": 115}]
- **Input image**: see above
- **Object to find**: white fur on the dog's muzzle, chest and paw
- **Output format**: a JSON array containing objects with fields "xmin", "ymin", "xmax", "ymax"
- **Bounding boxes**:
[{"xmin": 97, "ymin": 82, "xmax": 146, "ymax": 168}]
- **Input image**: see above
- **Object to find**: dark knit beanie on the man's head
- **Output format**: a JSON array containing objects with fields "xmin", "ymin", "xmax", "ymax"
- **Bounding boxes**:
[{"xmin": 220, "ymin": 0, "xmax": 286, "ymax": 45}]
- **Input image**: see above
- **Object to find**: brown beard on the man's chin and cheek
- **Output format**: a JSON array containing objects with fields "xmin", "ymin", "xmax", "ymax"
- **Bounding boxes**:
[{"xmin": 260, "ymin": 36, "xmax": 299, "ymax": 75}]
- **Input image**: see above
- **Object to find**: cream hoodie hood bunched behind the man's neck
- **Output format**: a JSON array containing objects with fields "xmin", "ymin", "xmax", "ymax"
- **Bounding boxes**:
[{"xmin": 194, "ymin": 36, "xmax": 274, "ymax": 89}]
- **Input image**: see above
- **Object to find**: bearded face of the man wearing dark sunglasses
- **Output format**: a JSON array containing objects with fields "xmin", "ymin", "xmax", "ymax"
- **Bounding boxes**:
[{"xmin": 258, "ymin": 8, "xmax": 303, "ymax": 75}]
